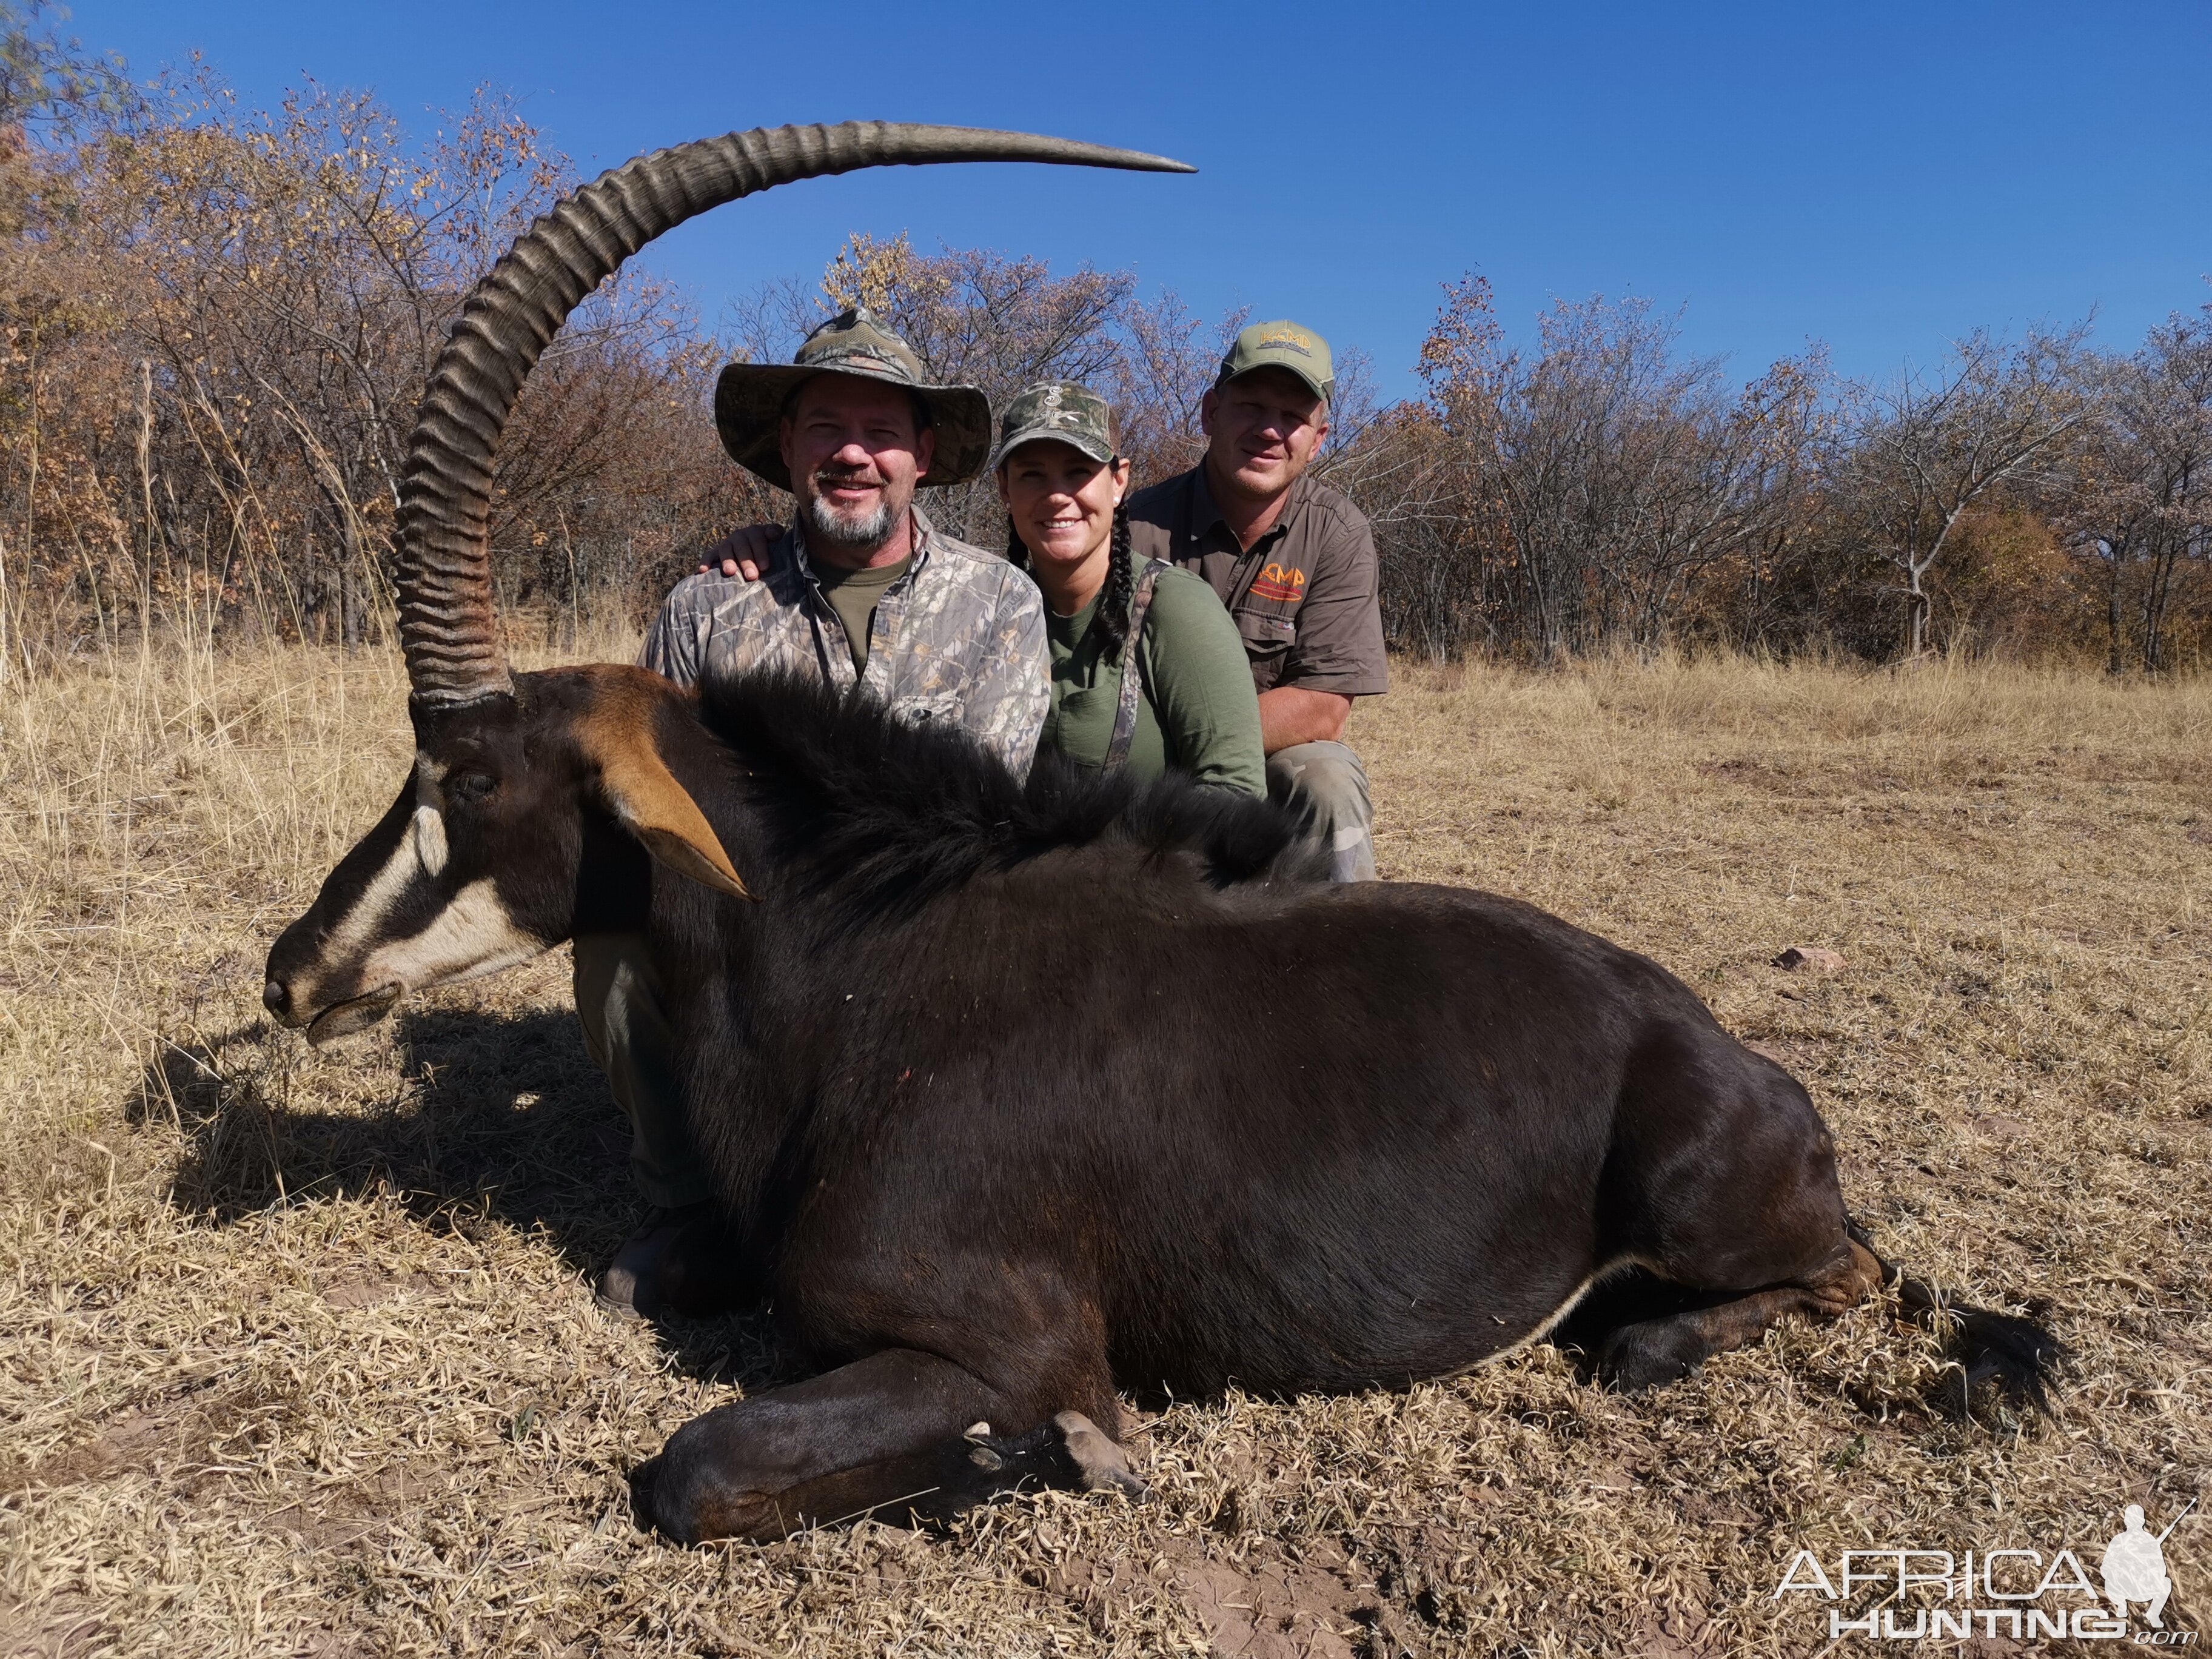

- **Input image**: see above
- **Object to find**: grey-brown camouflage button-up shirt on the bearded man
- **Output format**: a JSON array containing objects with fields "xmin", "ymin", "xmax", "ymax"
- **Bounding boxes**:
[{"xmin": 639, "ymin": 509, "xmax": 1053, "ymax": 776}]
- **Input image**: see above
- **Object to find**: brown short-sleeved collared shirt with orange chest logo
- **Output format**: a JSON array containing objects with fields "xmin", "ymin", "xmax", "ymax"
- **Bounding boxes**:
[{"xmin": 1128, "ymin": 462, "xmax": 1389, "ymax": 697}]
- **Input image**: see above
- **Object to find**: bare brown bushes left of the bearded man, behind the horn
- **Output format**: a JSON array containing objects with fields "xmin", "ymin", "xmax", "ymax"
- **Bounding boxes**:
[{"xmin": 0, "ymin": 27, "xmax": 759, "ymax": 663}]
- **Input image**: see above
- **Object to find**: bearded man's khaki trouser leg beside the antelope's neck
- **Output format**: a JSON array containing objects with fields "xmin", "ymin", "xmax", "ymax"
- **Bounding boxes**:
[{"xmin": 575, "ymin": 933, "xmax": 708, "ymax": 1210}]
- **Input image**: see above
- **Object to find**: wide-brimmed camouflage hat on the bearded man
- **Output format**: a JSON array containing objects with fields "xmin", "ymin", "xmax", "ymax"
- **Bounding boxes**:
[{"xmin": 714, "ymin": 305, "xmax": 991, "ymax": 489}]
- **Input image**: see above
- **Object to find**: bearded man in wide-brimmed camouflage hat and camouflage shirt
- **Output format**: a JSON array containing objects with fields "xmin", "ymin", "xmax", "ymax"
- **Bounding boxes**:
[{"xmin": 575, "ymin": 307, "xmax": 1051, "ymax": 1314}]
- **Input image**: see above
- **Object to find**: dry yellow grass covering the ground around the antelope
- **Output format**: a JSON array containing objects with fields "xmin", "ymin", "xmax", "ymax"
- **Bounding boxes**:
[{"xmin": 0, "ymin": 652, "xmax": 2212, "ymax": 1657}]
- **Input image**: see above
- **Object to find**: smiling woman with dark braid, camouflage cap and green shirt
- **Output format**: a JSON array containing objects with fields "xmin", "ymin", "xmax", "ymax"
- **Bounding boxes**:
[{"xmin": 991, "ymin": 380, "xmax": 1267, "ymax": 799}]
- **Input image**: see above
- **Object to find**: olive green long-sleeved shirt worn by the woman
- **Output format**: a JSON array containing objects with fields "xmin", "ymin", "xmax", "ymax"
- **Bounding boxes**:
[{"xmin": 1040, "ymin": 553, "xmax": 1267, "ymax": 796}]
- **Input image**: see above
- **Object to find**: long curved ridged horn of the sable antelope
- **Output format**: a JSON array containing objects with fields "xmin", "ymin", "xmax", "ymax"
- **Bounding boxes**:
[{"xmin": 398, "ymin": 122, "xmax": 1195, "ymax": 708}]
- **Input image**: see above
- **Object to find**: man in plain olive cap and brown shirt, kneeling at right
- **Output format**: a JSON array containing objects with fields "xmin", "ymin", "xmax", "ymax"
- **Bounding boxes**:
[{"xmin": 1128, "ymin": 321, "xmax": 1389, "ymax": 880}]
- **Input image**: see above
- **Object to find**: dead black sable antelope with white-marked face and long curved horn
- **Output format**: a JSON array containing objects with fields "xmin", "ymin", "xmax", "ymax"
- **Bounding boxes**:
[{"xmin": 266, "ymin": 126, "xmax": 2053, "ymax": 1540}]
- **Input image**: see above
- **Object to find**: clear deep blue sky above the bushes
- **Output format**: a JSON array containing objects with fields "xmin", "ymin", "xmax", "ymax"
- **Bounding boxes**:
[{"xmin": 71, "ymin": 0, "xmax": 2212, "ymax": 394}]
